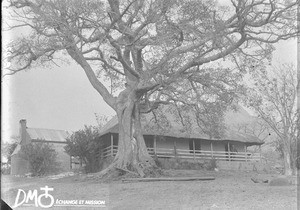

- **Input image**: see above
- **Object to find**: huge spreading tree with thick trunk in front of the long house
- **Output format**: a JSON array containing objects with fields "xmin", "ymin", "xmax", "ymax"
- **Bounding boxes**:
[{"xmin": 7, "ymin": 0, "xmax": 297, "ymax": 176}]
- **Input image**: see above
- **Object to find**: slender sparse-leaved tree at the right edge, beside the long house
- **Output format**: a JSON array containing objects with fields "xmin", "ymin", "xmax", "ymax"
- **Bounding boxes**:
[{"xmin": 246, "ymin": 64, "xmax": 299, "ymax": 175}]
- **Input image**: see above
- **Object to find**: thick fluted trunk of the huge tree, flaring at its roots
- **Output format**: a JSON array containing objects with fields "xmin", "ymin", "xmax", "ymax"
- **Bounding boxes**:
[{"xmin": 98, "ymin": 90, "xmax": 157, "ymax": 177}]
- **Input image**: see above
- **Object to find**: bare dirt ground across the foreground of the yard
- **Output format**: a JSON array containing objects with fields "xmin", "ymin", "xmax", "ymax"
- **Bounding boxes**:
[{"xmin": 1, "ymin": 170, "xmax": 299, "ymax": 210}]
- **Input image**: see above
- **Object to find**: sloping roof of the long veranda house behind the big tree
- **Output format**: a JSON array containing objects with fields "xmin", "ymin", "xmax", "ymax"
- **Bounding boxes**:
[{"xmin": 100, "ymin": 107, "xmax": 263, "ymax": 145}]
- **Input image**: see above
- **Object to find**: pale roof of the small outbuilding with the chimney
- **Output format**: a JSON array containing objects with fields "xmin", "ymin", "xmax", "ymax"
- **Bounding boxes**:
[{"xmin": 26, "ymin": 128, "xmax": 70, "ymax": 142}]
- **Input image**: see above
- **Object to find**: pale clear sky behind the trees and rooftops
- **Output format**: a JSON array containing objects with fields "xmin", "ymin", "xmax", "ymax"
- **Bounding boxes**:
[{"xmin": 1, "ymin": 1, "xmax": 297, "ymax": 142}]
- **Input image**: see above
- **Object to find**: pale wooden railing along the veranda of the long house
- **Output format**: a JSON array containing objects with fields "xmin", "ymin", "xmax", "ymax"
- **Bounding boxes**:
[{"xmin": 102, "ymin": 145, "xmax": 261, "ymax": 161}]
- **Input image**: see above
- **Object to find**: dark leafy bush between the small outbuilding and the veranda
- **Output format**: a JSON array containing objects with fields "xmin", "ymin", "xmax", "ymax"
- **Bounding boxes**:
[{"xmin": 64, "ymin": 126, "xmax": 101, "ymax": 172}]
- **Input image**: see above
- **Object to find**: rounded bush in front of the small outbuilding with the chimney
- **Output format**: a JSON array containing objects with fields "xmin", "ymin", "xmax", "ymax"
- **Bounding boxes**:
[{"xmin": 21, "ymin": 142, "xmax": 59, "ymax": 176}]
